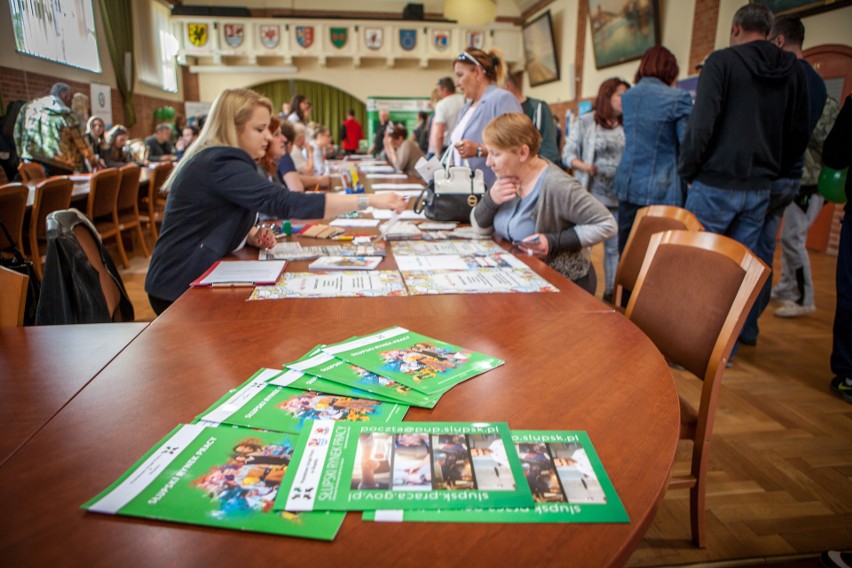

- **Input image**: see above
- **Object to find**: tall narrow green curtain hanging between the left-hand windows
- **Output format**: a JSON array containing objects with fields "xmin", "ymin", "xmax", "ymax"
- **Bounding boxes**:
[{"xmin": 100, "ymin": 0, "xmax": 136, "ymax": 127}]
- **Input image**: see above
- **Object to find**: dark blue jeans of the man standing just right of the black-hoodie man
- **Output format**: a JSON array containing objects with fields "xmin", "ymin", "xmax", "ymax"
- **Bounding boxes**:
[{"xmin": 734, "ymin": 179, "xmax": 801, "ymax": 344}]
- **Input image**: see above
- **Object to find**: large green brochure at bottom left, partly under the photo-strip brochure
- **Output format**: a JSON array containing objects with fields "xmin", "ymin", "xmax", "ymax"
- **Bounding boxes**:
[{"xmin": 83, "ymin": 424, "xmax": 344, "ymax": 540}]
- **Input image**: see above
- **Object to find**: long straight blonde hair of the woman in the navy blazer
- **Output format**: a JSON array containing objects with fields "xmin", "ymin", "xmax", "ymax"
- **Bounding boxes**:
[{"xmin": 163, "ymin": 89, "xmax": 272, "ymax": 189}]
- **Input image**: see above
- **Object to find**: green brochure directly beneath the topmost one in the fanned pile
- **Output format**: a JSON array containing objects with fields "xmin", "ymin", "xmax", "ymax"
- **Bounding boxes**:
[{"xmin": 284, "ymin": 351, "xmax": 447, "ymax": 408}]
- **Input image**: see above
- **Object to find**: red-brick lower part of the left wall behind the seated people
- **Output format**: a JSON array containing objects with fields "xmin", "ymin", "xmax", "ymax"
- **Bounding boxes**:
[{"xmin": 0, "ymin": 66, "xmax": 186, "ymax": 138}]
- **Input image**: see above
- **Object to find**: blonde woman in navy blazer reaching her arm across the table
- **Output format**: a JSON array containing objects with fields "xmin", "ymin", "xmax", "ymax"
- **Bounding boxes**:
[{"xmin": 145, "ymin": 89, "xmax": 405, "ymax": 314}]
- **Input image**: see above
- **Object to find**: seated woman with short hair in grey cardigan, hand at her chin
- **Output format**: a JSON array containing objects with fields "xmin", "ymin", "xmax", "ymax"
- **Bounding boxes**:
[{"xmin": 470, "ymin": 113, "xmax": 616, "ymax": 294}]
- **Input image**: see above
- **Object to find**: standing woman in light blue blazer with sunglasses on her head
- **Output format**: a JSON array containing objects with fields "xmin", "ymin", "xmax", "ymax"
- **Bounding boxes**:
[{"xmin": 450, "ymin": 47, "xmax": 523, "ymax": 187}]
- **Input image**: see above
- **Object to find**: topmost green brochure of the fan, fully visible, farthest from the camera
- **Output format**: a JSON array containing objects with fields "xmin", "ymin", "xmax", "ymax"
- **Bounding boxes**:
[{"xmin": 323, "ymin": 327, "xmax": 503, "ymax": 395}]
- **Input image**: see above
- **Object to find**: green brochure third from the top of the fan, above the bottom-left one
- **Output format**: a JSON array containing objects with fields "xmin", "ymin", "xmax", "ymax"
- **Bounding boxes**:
[{"xmin": 198, "ymin": 369, "xmax": 408, "ymax": 433}]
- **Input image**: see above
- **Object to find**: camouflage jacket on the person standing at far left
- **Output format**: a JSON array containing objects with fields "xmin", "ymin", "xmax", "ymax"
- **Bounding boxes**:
[{"xmin": 15, "ymin": 95, "xmax": 92, "ymax": 172}]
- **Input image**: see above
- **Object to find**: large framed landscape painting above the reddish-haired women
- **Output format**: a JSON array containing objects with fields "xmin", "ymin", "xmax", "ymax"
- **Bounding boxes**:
[{"xmin": 588, "ymin": 0, "xmax": 660, "ymax": 69}]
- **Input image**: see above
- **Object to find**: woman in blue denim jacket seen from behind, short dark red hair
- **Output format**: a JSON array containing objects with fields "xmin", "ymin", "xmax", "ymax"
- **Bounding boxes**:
[{"xmin": 614, "ymin": 46, "xmax": 692, "ymax": 254}]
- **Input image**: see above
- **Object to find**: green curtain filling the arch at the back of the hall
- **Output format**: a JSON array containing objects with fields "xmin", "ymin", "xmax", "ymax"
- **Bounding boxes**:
[{"xmin": 252, "ymin": 79, "xmax": 367, "ymax": 146}]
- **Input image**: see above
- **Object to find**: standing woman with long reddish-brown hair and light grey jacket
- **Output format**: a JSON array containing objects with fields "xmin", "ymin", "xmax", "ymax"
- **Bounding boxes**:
[{"xmin": 562, "ymin": 78, "xmax": 630, "ymax": 301}]
